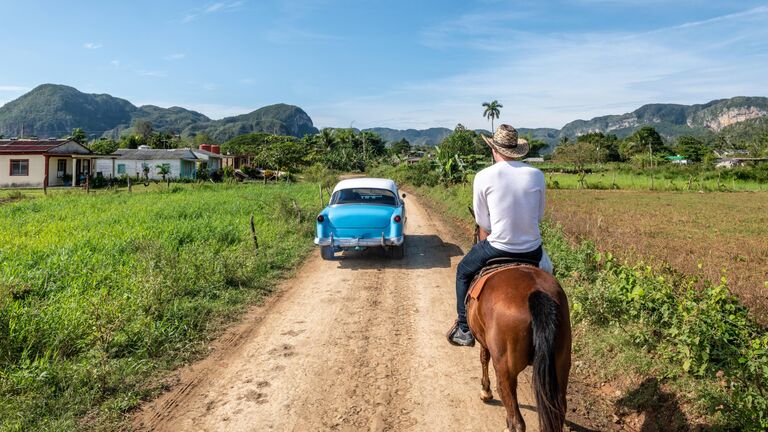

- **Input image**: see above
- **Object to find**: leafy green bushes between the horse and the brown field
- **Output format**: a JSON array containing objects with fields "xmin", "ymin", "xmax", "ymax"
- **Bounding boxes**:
[{"xmin": 545, "ymin": 229, "xmax": 768, "ymax": 431}]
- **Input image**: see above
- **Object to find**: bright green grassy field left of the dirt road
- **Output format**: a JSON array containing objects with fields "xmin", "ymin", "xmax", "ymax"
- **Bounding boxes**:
[{"xmin": 0, "ymin": 184, "xmax": 318, "ymax": 431}]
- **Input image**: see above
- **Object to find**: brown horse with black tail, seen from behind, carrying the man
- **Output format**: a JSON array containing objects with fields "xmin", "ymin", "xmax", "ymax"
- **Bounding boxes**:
[{"xmin": 467, "ymin": 213, "xmax": 571, "ymax": 432}]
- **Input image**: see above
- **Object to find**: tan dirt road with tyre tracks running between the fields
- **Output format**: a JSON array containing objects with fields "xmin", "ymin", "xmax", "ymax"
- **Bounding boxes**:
[{"xmin": 133, "ymin": 197, "xmax": 537, "ymax": 432}]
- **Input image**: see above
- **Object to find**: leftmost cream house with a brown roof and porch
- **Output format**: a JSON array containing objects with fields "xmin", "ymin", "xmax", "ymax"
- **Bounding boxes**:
[{"xmin": 0, "ymin": 139, "xmax": 111, "ymax": 188}]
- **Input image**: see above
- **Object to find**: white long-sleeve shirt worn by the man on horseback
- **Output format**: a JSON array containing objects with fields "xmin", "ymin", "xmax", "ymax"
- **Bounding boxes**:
[{"xmin": 472, "ymin": 161, "xmax": 546, "ymax": 253}]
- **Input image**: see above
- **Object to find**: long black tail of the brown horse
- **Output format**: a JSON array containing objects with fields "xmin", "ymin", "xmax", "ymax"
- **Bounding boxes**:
[{"xmin": 528, "ymin": 291, "xmax": 565, "ymax": 432}]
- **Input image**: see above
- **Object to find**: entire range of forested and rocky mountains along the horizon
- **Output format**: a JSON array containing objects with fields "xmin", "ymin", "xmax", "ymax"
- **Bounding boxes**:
[{"xmin": 0, "ymin": 84, "xmax": 768, "ymax": 149}]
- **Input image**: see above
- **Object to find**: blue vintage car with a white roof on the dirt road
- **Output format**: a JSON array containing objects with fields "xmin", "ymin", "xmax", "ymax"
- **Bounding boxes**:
[{"xmin": 315, "ymin": 178, "xmax": 406, "ymax": 260}]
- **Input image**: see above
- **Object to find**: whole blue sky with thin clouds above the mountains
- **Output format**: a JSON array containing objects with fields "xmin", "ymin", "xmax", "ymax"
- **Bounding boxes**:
[{"xmin": 0, "ymin": 0, "xmax": 768, "ymax": 128}]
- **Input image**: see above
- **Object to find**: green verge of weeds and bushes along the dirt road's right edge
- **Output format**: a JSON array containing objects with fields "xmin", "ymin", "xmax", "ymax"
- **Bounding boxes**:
[{"xmin": 416, "ymin": 181, "xmax": 768, "ymax": 431}]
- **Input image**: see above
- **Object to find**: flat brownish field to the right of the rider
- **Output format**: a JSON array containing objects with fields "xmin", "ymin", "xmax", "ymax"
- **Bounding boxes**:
[{"xmin": 547, "ymin": 190, "xmax": 768, "ymax": 323}]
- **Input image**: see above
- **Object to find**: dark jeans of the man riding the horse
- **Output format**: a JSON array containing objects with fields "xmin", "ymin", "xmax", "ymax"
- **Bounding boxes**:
[{"xmin": 456, "ymin": 240, "xmax": 542, "ymax": 331}]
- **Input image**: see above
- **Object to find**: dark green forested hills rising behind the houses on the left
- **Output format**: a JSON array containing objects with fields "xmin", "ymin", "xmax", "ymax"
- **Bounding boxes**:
[{"xmin": 0, "ymin": 84, "xmax": 317, "ymax": 142}]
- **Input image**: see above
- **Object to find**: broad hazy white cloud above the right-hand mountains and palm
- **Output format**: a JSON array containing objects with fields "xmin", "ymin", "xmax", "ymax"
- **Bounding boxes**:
[{"xmin": 307, "ymin": 7, "xmax": 768, "ymax": 128}]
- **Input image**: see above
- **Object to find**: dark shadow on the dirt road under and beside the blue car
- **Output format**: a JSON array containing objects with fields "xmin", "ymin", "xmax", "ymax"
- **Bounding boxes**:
[{"xmin": 336, "ymin": 234, "xmax": 464, "ymax": 270}]
